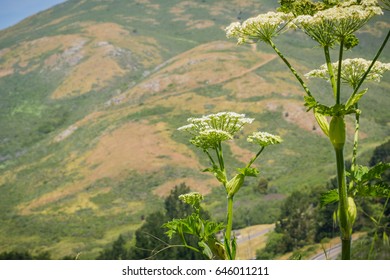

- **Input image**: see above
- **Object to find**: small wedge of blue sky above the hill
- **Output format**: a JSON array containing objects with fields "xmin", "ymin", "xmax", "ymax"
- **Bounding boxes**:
[{"xmin": 0, "ymin": 0, "xmax": 66, "ymax": 30}]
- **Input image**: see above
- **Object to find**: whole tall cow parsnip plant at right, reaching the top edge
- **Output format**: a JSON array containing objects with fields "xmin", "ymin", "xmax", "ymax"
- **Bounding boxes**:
[{"xmin": 226, "ymin": 0, "xmax": 390, "ymax": 259}]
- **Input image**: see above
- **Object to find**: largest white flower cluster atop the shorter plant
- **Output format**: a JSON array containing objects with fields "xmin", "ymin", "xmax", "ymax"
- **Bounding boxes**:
[{"xmin": 178, "ymin": 112, "xmax": 254, "ymax": 150}]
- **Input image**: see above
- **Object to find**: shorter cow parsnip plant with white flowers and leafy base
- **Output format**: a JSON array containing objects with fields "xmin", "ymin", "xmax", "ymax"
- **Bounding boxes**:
[{"xmin": 164, "ymin": 112, "xmax": 282, "ymax": 260}]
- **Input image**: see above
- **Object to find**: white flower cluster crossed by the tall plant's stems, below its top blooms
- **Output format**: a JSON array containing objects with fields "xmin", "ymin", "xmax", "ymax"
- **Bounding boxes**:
[{"xmin": 305, "ymin": 58, "xmax": 390, "ymax": 88}]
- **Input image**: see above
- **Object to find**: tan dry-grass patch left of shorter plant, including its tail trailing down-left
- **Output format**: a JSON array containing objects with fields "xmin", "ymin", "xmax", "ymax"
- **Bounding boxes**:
[{"xmin": 18, "ymin": 118, "xmax": 201, "ymax": 215}]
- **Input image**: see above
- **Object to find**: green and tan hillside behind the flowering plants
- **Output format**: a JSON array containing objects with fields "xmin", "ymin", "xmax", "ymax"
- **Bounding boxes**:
[{"xmin": 0, "ymin": 0, "xmax": 390, "ymax": 258}]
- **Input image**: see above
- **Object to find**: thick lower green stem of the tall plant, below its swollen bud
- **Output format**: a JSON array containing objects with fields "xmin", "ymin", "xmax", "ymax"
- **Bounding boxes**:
[{"xmin": 335, "ymin": 148, "xmax": 352, "ymax": 260}]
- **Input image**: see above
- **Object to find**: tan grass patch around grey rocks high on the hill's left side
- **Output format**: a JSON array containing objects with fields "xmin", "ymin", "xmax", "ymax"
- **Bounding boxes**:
[{"xmin": 52, "ymin": 22, "xmax": 161, "ymax": 99}]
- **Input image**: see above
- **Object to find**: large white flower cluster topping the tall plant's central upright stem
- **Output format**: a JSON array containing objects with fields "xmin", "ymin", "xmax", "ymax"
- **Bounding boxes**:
[{"xmin": 293, "ymin": 0, "xmax": 383, "ymax": 46}]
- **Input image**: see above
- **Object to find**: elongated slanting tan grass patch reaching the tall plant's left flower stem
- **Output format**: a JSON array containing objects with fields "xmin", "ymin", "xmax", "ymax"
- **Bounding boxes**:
[{"xmin": 120, "ymin": 41, "xmax": 275, "ymax": 103}]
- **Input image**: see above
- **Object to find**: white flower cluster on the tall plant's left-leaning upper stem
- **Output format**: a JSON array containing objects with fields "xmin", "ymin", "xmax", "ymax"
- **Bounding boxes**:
[{"xmin": 225, "ymin": 12, "xmax": 293, "ymax": 44}]
